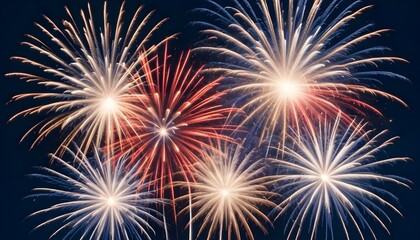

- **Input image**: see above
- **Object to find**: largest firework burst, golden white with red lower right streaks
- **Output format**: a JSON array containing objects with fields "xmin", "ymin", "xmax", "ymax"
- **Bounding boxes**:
[{"xmin": 198, "ymin": 0, "xmax": 404, "ymax": 150}]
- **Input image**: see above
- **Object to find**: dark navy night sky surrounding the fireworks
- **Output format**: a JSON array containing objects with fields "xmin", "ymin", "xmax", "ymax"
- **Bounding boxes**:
[{"xmin": 0, "ymin": 0, "xmax": 420, "ymax": 240}]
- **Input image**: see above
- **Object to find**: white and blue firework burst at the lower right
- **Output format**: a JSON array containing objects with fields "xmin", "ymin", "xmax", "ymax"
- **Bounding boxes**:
[{"xmin": 274, "ymin": 116, "xmax": 409, "ymax": 239}]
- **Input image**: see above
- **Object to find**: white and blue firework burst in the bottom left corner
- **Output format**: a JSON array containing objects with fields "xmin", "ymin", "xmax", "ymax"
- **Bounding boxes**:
[{"xmin": 30, "ymin": 145, "xmax": 162, "ymax": 239}]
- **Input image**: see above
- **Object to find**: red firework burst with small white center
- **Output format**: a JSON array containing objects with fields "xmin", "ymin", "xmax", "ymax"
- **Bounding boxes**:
[{"xmin": 116, "ymin": 45, "xmax": 236, "ymax": 199}]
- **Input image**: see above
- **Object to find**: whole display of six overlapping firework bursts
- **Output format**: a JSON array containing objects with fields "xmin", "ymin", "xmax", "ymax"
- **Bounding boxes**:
[{"xmin": 7, "ymin": 0, "xmax": 412, "ymax": 240}]
